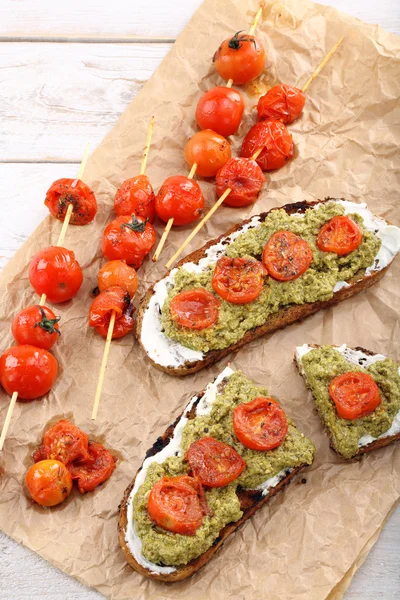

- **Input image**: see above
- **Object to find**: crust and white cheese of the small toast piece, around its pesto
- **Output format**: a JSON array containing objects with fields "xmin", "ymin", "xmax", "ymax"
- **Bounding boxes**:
[{"xmin": 294, "ymin": 344, "xmax": 400, "ymax": 460}]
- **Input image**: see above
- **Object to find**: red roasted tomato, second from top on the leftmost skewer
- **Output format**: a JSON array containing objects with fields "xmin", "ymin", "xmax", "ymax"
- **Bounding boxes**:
[{"xmin": 29, "ymin": 246, "xmax": 83, "ymax": 304}]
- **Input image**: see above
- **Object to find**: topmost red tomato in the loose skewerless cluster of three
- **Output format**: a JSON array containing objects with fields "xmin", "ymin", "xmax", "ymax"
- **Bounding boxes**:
[{"xmin": 43, "ymin": 419, "xmax": 90, "ymax": 465}]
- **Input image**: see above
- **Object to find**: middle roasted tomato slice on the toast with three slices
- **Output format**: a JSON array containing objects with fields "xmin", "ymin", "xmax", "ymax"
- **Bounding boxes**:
[{"xmin": 186, "ymin": 437, "xmax": 246, "ymax": 487}]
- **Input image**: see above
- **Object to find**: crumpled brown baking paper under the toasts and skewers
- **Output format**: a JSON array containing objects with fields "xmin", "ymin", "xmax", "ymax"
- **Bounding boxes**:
[{"xmin": 0, "ymin": 0, "xmax": 400, "ymax": 600}]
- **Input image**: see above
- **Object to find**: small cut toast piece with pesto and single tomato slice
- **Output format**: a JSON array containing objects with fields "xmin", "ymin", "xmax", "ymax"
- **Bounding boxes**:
[{"xmin": 295, "ymin": 344, "xmax": 400, "ymax": 459}]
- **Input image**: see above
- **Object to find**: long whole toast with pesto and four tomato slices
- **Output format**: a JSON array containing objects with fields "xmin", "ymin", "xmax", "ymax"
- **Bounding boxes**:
[{"xmin": 137, "ymin": 199, "xmax": 400, "ymax": 376}]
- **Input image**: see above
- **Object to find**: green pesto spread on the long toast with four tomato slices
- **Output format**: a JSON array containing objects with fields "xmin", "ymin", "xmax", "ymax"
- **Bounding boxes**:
[{"xmin": 161, "ymin": 202, "xmax": 381, "ymax": 352}]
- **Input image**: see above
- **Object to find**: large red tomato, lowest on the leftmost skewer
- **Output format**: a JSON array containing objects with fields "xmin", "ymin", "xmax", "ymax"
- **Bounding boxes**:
[{"xmin": 0, "ymin": 344, "xmax": 58, "ymax": 400}]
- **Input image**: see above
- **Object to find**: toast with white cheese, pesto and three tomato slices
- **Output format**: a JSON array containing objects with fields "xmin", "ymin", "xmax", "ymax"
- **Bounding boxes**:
[{"xmin": 119, "ymin": 367, "xmax": 315, "ymax": 581}]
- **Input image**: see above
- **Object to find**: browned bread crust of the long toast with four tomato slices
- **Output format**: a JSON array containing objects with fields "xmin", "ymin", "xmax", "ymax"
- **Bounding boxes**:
[{"xmin": 136, "ymin": 198, "xmax": 390, "ymax": 377}]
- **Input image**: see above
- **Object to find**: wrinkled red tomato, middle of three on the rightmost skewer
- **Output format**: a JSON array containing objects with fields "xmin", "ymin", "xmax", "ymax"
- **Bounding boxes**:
[{"xmin": 240, "ymin": 121, "xmax": 293, "ymax": 171}]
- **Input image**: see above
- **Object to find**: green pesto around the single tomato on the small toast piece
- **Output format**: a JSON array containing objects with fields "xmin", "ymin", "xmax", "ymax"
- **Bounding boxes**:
[{"xmin": 301, "ymin": 346, "xmax": 400, "ymax": 458}]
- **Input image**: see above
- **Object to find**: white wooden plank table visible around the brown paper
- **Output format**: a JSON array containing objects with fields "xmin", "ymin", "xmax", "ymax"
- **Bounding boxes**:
[{"xmin": 0, "ymin": 0, "xmax": 400, "ymax": 600}]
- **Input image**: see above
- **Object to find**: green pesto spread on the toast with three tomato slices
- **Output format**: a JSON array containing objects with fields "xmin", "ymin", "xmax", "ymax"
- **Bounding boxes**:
[{"xmin": 133, "ymin": 371, "xmax": 315, "ymax": 565}]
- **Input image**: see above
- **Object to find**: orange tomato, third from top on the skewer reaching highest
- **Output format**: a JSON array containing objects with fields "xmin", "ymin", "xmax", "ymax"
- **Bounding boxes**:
[{"xmin": 185, "ymin": 129, "xmax": 231, "ymax": 177}]
